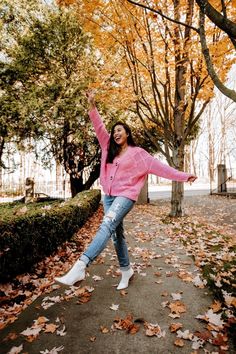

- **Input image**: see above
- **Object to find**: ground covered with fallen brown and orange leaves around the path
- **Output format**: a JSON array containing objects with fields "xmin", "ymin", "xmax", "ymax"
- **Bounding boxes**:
[{"xmin": 0, "ymin": 197, "xmax": 236, "ymax": 354}]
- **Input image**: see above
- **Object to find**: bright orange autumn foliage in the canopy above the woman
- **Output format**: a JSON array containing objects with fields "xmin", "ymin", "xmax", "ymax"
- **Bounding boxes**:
[{"xmin": 57, "ymin": 0, "xmax": 236, "ymax": 129}]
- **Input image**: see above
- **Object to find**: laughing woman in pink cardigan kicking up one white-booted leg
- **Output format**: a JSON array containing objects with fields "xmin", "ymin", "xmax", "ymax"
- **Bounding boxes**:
[{"xmin": 55, "ymin": 92, "xmax": 197, "ymax": 290}]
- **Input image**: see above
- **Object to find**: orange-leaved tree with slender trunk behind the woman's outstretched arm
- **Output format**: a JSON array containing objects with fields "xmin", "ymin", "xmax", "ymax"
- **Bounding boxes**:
[{"xmin": 56, "ymin": 1, "xmax": 220, "ymax": 215}]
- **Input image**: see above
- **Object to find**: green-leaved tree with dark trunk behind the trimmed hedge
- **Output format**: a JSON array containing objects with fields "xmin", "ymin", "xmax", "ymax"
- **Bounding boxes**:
[{"xmin": 0, "ymin": 2, "xmax": 104, "ymax": 196}]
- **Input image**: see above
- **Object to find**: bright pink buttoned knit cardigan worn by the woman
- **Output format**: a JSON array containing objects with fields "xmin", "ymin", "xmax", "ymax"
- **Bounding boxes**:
[{"xmin": 89, "ymin": 108, "xmax": 191, "ymax": 200}]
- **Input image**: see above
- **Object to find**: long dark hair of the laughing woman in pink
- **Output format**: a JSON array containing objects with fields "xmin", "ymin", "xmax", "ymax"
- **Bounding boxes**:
[{"xmin": 106, "ymin": 121, "xmax": 136, "ymax": 163}]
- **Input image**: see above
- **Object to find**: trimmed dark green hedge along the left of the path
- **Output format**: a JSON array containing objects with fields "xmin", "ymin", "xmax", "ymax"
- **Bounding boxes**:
[{"xmin": 0, "ymin": 190, "xmax": 101, "ymax": 282}]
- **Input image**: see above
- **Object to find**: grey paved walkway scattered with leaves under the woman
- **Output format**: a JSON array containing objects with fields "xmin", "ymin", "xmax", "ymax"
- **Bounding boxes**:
[{"xmin": 0, "ymin": 198, "xmax": 233, "ymax": 354}]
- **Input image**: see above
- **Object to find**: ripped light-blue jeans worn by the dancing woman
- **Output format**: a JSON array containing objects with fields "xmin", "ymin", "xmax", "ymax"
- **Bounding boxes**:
[{"xmin": 80, "ymin": 195, "xmax": 135, "ymax": 270}]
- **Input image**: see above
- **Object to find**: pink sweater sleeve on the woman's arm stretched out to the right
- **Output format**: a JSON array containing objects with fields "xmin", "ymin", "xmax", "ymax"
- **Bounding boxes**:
[{"xmin": 146, "ymin": 153, "xmax": 191, "ymax": 182}]
